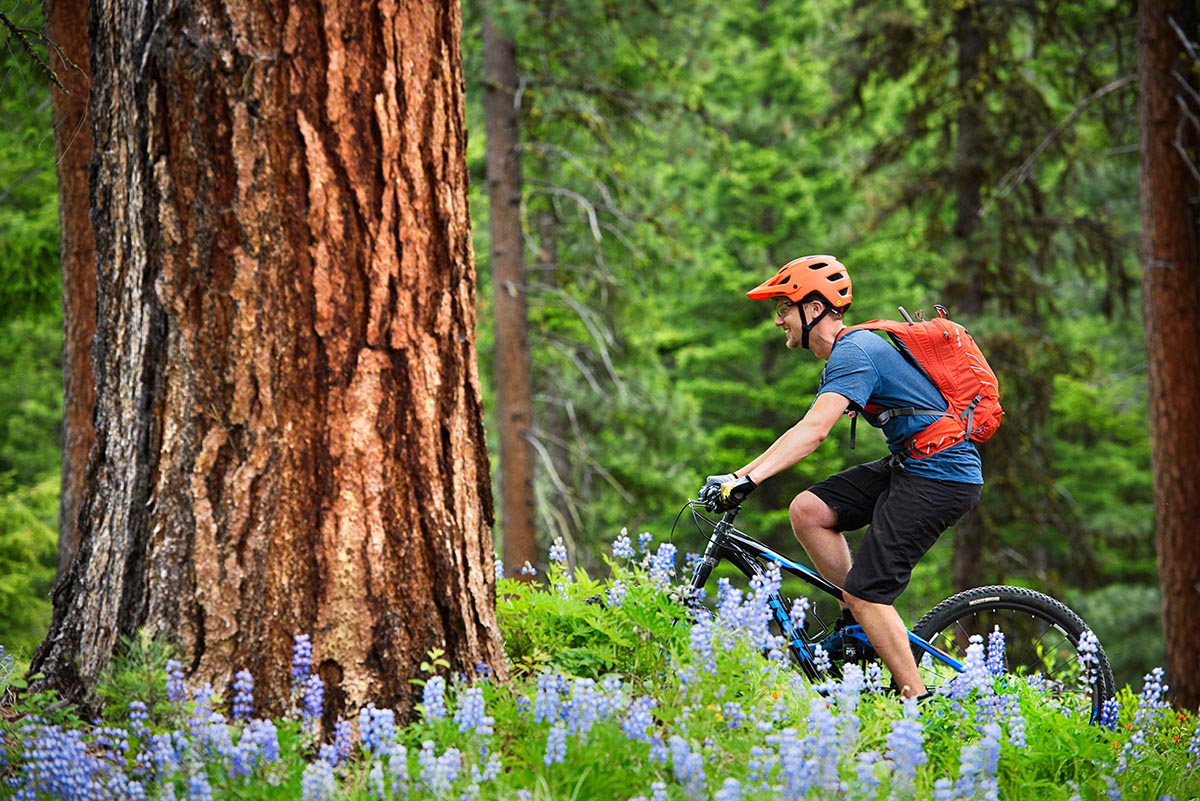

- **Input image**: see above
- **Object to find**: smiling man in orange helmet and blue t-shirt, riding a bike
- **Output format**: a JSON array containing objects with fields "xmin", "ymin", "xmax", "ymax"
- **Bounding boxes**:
[{"xmin": 700, "ymin": 255, "xmax": 983, "ymax": 697}]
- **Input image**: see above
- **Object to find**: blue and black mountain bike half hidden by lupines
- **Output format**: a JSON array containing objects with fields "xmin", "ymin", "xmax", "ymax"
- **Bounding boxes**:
[{"xmin": 677, "ymin": 500, "xmax": 1116, "ymax": 722}]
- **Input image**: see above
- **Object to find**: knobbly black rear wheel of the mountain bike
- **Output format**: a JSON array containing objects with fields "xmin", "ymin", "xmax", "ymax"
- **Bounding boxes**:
[{"xmin": 912, "ymin": 586, "xmax": 1116, "ymax": 721}]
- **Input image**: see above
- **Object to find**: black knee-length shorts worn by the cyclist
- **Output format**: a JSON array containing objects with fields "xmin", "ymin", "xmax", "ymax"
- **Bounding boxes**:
[{"xmin": 809, "ymin": 457, "xmax": 983, "ymax": 604}]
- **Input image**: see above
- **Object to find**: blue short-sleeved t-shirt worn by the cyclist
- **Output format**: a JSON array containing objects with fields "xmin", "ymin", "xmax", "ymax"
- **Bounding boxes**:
[{"xmin": 817, "ymin": 330, "xmax": 983, "ymax": 484}]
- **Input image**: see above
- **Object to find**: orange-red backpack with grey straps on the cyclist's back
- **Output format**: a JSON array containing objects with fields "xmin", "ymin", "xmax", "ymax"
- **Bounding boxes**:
[{"xmin": 838, "ymin": 306, "xmax": 1004, "ymax": 459}]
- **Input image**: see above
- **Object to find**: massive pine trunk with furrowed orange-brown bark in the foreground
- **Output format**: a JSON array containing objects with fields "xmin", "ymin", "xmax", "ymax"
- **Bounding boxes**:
[{"xmin": 34, "ymin": 0, "xmax": 504, "ymax": 712}]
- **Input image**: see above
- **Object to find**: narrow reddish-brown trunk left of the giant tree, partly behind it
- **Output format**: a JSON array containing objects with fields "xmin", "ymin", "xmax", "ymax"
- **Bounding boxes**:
[{"xmin": 43, "ymin": 0, "xmax": 96, "ymax": 576}]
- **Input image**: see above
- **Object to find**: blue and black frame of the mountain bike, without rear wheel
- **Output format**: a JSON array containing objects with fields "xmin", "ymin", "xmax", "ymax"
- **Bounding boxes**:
[{"xmin": 688, "ymin": 500, "xmax": 965, "ymax": 679}]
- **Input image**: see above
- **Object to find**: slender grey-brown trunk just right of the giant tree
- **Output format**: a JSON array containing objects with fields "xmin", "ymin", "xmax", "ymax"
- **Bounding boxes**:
[{"xmin": 484, "ymin": 9, "xmax": 538, "ymax": 577}]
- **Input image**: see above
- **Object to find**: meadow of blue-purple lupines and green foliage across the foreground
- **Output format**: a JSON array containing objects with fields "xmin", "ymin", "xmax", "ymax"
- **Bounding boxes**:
[{"xmin": 0, "ymin": 532, "xmax": 1200, "ymax": 801}]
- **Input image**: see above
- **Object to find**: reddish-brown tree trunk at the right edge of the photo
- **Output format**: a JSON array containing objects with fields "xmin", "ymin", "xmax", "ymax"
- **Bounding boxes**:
[{"xmin": 1138, "ymin": 0, "xmax": 1200, "ymax": 710}]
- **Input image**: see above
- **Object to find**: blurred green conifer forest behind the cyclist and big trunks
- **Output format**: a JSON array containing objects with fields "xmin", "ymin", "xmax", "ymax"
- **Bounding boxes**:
[{"xmin": 0, "ymin": 0, "xmax": 1163, "ymax": 683}]
